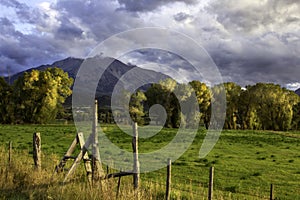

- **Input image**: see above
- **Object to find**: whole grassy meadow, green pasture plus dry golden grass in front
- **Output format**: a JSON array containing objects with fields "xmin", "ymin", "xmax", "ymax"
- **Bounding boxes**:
[{"xmin": 0, "ymin": 124, "xmax": 300, "ymax": 200}]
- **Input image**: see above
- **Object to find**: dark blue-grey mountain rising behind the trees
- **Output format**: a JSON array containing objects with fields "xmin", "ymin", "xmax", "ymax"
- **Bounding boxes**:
[{"xmin": 10, "ymin": 56, "xmax": 170, "ymax": 103}]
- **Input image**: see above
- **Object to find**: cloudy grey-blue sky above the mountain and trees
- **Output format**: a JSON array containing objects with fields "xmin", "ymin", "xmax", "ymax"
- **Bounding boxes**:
[{"xmin": 0, "ymin": 0, "xmax": 300, "ymax": 90}]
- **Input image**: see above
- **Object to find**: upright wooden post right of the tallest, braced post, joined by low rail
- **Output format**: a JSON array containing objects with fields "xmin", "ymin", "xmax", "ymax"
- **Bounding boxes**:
[{"xmin": 132, "ymin": 122, "xmax": 140, "ymax": 195}]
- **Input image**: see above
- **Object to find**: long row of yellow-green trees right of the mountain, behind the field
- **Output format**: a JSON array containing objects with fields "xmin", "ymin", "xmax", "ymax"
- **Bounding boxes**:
[{"xmin": 130, "ymin": 79, "xmax": 300, "ymax": 131}]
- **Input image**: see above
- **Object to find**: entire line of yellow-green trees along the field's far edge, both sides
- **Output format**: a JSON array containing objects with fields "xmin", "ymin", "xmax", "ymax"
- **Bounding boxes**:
[{"xmin": 0, "ymin": 68, "xmax": 300, "ymax": 131}]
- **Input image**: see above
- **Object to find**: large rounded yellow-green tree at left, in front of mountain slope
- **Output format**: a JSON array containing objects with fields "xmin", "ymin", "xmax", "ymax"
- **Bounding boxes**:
[{"xmin": 13, "ymin": 68, "xmax": 73, "ymax": 123}]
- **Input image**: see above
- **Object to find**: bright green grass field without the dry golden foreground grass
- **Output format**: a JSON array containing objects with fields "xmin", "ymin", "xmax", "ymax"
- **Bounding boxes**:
[{"xmin": 0, "ymin": 125, "xmax": 300, "ymax": 199}]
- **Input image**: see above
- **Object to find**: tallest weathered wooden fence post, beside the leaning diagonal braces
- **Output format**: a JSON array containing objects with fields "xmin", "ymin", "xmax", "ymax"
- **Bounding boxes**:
[{"xmin": 92, "ymin": 100, "xmax": 104, "ymax": 180}]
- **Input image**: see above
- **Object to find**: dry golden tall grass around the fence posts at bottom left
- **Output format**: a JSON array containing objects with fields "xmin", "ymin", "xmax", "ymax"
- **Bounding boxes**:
[{"xmin": 0, "ymin": 146, "xmax": 209, "ymax": 200}]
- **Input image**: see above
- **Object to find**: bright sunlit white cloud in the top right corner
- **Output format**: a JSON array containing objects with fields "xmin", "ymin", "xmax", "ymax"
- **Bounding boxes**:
[{"xmin": 209, "ymin": 0, "xmax": 300, "ymax": 32}]
